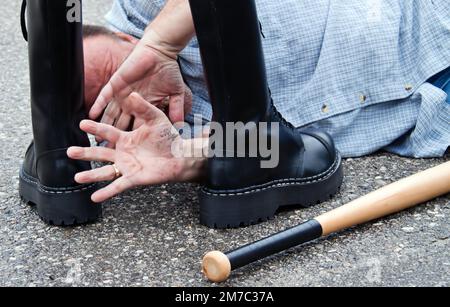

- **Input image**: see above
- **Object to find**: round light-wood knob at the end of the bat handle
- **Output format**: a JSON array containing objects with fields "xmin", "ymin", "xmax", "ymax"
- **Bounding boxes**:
[{"xmin": 202, "ymin": 251, "xmax": 231, "ymax": 283}]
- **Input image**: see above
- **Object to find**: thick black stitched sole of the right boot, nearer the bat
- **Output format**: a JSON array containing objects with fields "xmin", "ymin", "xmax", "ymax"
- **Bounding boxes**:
[{"xmin": 200, "ymin": 155, "xmax": 344, "ymax": 229}]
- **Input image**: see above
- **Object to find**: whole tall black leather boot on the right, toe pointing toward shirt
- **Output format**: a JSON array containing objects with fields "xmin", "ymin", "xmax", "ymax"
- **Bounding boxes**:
[{"xmin": 190, "ymin": 0, "xmax": 343, "ymax": 228}]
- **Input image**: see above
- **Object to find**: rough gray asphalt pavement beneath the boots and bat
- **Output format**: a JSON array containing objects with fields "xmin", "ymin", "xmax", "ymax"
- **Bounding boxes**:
[{"xmin": 0, "ymin": 0, "xmax": 450, "ymax": 286}]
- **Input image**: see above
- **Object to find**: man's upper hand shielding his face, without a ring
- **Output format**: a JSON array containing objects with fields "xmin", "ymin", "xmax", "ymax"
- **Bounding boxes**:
[{"xmin": 89, "ymin": 40, "xmax": 192, "ymax": 132}]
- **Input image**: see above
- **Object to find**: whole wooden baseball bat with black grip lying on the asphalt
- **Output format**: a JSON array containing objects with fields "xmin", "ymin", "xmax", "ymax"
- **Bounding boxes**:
[{"xmin": 202, "ymin": 162, "xmax": 450, "ymax": 283}]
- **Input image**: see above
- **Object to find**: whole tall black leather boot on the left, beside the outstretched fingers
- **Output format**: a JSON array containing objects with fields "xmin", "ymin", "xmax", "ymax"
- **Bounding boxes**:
[{"xmin": 20, "ymin": 0, "xmax": 102, "ymax": 226}]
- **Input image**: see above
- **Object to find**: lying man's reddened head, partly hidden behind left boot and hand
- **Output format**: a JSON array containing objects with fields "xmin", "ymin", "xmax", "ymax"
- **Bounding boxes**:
[{"xmin": 83, "ymin": 25, "xmax": 138, "ymax": 110}]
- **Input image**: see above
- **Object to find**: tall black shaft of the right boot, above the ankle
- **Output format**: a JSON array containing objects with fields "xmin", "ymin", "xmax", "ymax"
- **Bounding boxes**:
[{"xmin": 190, "ymin": 0, "xmax": 270, "ymax": 125}]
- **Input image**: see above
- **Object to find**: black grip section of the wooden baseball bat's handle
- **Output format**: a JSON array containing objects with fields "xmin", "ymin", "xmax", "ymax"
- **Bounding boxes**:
[{"xmin": 226, "ymin": 220, "xmax": 323, "ymax": 270}]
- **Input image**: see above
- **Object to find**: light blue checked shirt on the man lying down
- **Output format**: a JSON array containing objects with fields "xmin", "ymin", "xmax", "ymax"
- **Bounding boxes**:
[{"xmin": 106, "ymin": 0, "xmax": 450, "ymax": 157}]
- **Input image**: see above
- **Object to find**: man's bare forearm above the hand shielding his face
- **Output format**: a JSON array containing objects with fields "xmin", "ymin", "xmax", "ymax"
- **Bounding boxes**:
[{"xmin": 141, "ymin": 0, "xmax": 195, "ymax": 59}]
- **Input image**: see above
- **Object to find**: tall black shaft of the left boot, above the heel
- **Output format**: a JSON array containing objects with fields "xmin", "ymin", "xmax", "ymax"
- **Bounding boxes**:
[{"xmin": 26, "ymin": 0, "xmax": 89, "ymax": 156}]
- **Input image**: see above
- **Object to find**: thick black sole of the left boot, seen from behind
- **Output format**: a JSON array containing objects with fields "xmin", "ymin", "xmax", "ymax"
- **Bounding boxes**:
[{"xmin": 19, "ymin": 169, "xmax": 102, "ymax": 226}]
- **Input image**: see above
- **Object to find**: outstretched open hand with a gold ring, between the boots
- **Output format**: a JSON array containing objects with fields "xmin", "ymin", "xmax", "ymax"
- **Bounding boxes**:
[{"xmin": 67, "ymin": 93, "xmax": 199, "ymax": 203}]
